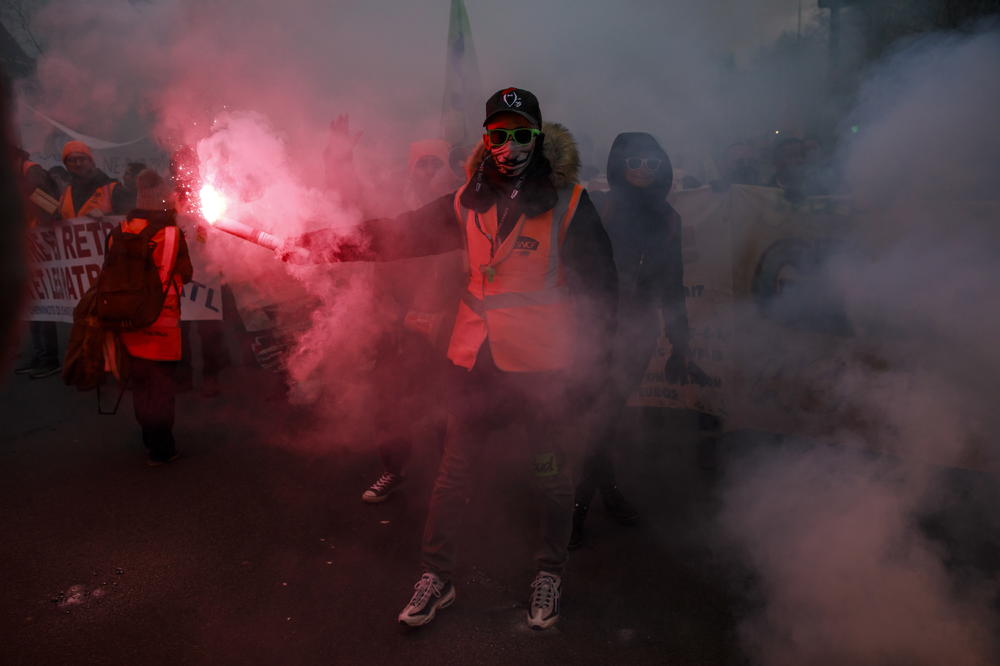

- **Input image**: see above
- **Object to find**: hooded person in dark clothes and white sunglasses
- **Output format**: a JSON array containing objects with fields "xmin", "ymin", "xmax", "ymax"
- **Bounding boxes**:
[{"xmin": 570, "ymin": 132, "xmax": 697, "ymax": 549}]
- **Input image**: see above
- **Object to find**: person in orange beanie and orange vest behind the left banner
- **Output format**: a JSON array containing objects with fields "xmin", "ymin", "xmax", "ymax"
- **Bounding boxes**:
[{"xmin": 57, "ymin": 141, "xmax": 131, "ymax": 220}]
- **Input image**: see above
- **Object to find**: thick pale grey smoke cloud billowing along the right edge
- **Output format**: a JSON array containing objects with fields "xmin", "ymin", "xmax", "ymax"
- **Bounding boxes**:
[{"xmin": 722, "ymin": 26, "xmax": 1000, "ymax": 666}]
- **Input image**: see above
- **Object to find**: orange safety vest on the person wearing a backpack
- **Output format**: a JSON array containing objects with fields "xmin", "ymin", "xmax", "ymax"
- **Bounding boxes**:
[{"xmin": 114, "ymin": 217, "xmax": 183, "ymax": 361}]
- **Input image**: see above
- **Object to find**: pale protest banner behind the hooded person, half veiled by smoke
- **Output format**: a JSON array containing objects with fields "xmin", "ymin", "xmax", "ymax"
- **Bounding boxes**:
[{"xmin": 631, "ymin": 186, "xmax": 850, "ymax": 434}]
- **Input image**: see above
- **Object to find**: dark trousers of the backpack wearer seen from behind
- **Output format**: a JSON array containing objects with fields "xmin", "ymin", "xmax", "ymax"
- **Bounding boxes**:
[{"xmin": 129, "ymin": 356, "xmax": 177, "ymax": 461}]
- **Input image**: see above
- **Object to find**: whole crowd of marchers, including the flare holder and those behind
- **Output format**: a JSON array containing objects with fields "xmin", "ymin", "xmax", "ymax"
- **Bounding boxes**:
[{"xmin": 15, "ymin": 88, "xmax": 840, "ymax": 629}]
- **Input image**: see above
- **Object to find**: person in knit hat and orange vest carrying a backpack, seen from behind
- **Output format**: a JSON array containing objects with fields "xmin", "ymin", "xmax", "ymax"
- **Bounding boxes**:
[{"xmin": 111, "ymin": 169, "xmax": 194, "ymax": 467}]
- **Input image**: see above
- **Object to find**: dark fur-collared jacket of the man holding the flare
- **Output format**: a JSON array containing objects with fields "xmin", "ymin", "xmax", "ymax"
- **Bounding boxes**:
[{"xmin": 300, "ymin": 123, "xmax": 618, "ymax": 358}]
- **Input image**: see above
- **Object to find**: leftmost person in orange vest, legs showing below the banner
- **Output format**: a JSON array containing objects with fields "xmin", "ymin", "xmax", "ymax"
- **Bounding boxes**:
[{"xmin": 14, "ymin": 148, "xmax": 62, "ymax": 379}]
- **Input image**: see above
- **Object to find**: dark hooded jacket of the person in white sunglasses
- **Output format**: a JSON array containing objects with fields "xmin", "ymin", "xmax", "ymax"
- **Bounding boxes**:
[{"xmin": 598, "ymin": 132, "xmax": 689, "ymax": 353}]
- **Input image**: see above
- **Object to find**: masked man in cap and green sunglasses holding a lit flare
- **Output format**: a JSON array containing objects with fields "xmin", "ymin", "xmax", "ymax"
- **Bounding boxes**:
[{"xmin": 280, "ymin": 88, "xmax": 618, "ymax": 629}]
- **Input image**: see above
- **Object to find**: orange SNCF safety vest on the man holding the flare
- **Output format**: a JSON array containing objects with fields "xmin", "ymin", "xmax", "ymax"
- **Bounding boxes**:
[{"xmin": 448, "ymin": 185, "xmax": 584, "ymax": 372}]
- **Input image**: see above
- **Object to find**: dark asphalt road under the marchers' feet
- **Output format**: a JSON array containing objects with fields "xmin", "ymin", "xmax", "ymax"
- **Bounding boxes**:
[{"xmin": 7, "ymin": 331, "xmax": 1000, "ymax": 666}]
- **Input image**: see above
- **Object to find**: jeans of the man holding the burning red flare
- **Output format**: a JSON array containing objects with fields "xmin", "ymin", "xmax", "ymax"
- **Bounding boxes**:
[{"xmin": 422, "ymin": 345, "xmax": 573, "ymax": 580}]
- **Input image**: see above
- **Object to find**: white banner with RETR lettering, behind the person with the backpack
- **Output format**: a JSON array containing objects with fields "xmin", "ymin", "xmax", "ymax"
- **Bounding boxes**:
[{"xmin": 28, "ymin": 216, "xmax": 222, "ymax": 322}]
